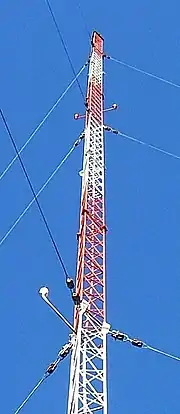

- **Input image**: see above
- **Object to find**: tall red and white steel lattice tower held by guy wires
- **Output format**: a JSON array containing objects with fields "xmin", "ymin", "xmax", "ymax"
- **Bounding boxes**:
[{"xmin": 68, "ymin": 32, "xmax": 108, "ymax": 414}]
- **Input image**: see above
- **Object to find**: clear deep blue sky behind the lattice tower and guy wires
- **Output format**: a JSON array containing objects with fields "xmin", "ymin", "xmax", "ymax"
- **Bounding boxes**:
[{"xmin": 0, "ymin": 0, "xmax": 180, "ymax": 414}]
